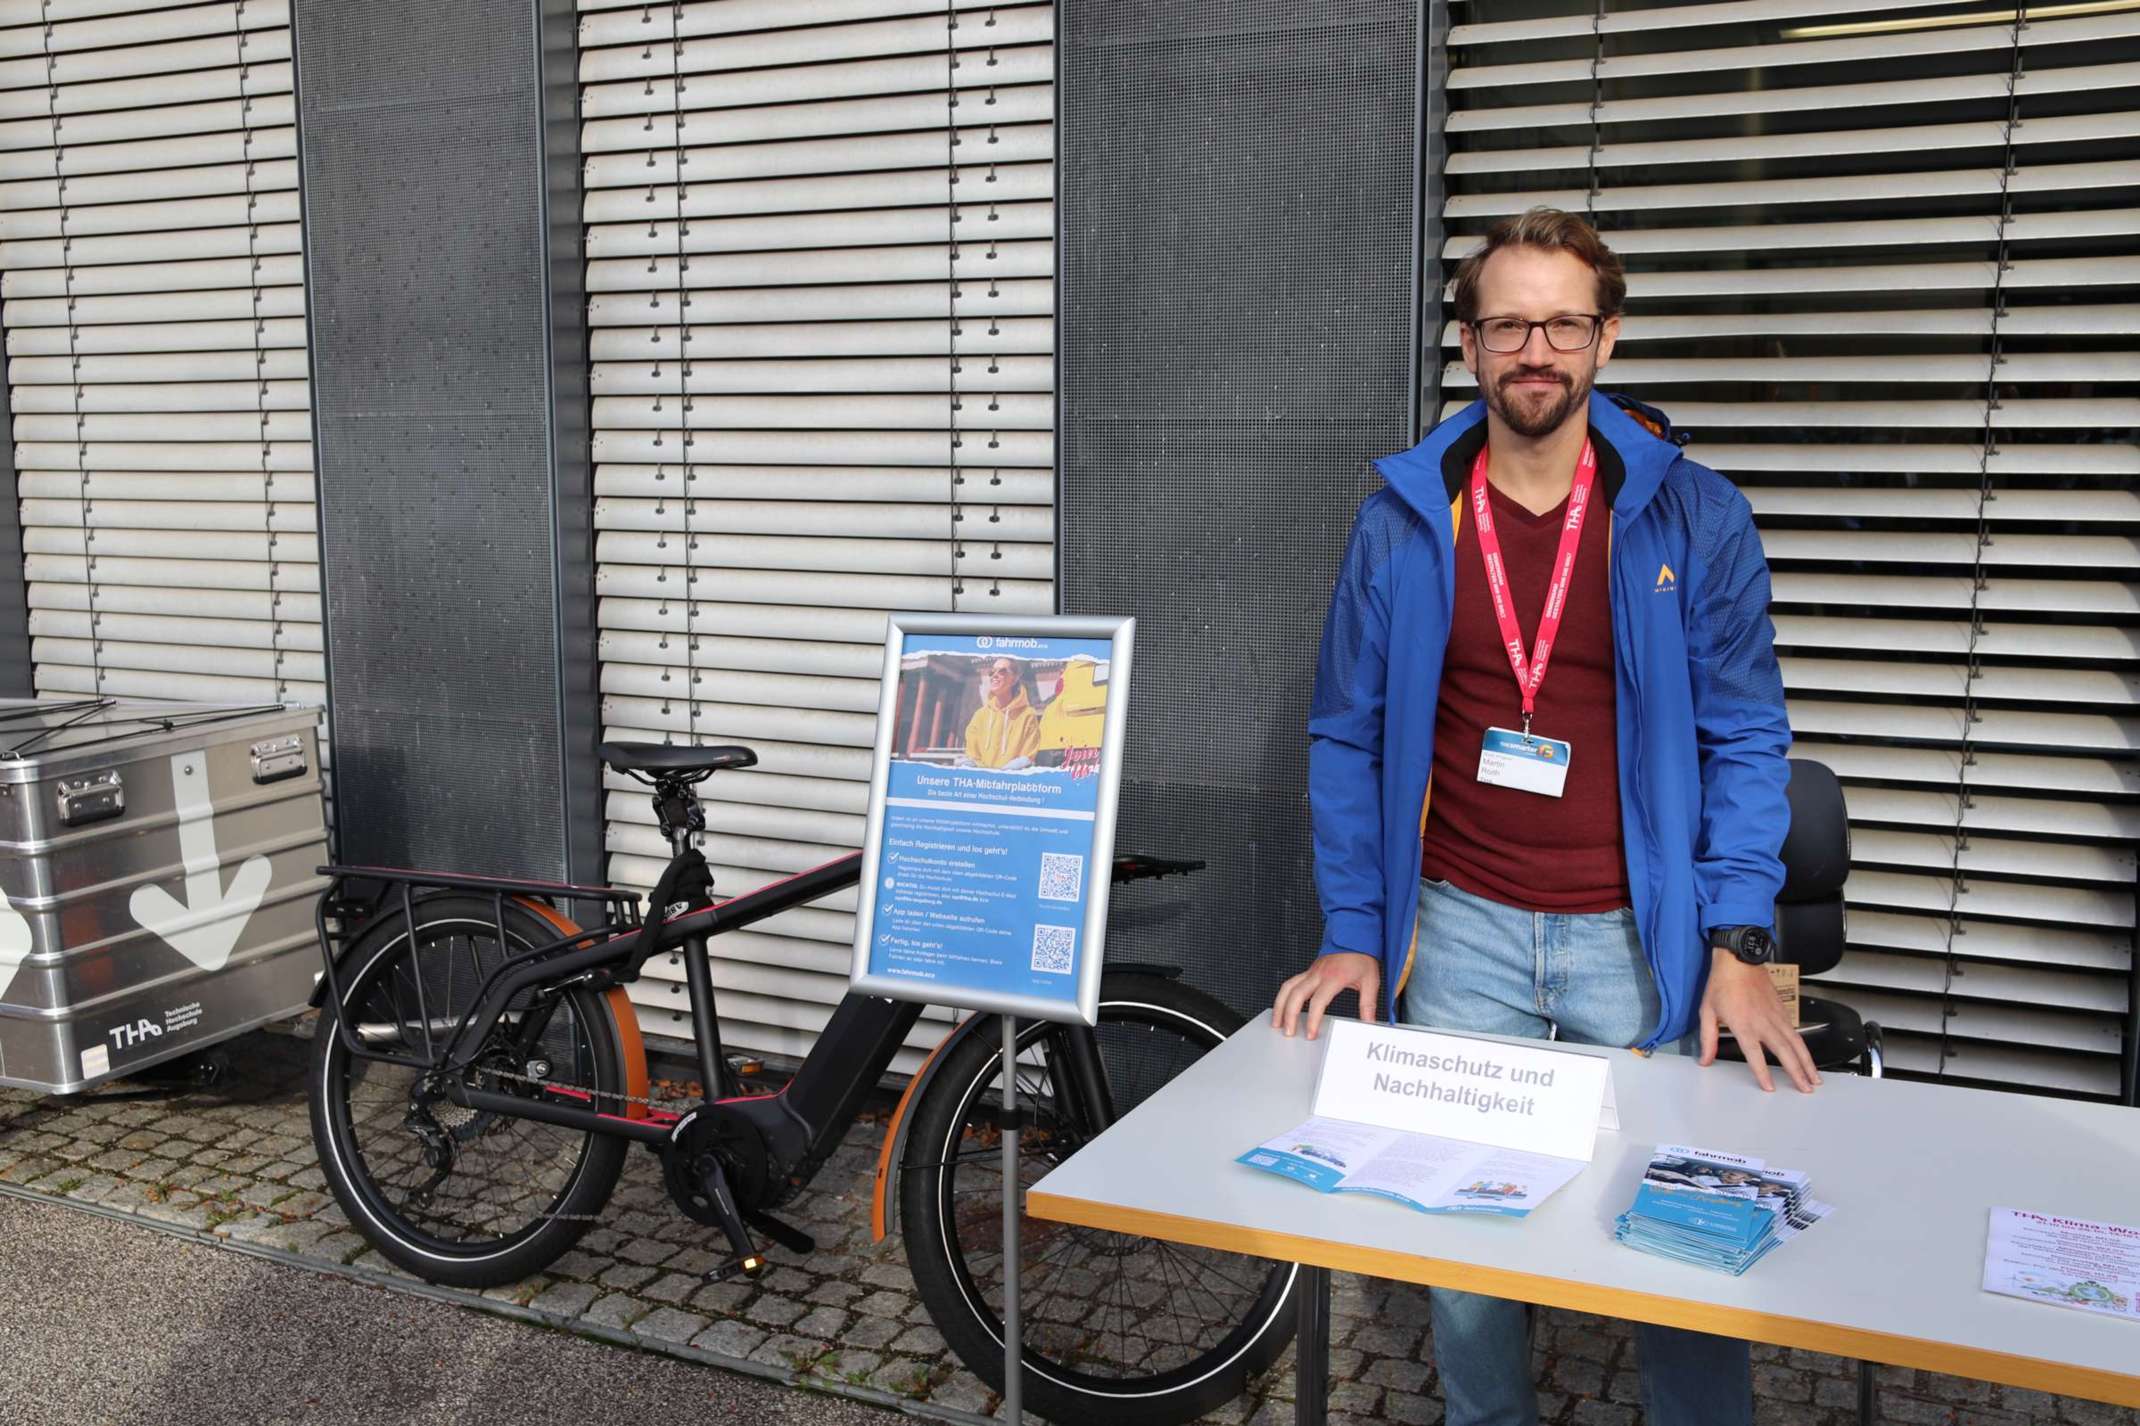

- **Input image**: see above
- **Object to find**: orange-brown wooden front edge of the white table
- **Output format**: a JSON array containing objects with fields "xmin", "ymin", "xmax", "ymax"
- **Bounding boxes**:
[{"xmin": 1025, "ymin": 1188, "xmax": 2140, "ymax": 1407}]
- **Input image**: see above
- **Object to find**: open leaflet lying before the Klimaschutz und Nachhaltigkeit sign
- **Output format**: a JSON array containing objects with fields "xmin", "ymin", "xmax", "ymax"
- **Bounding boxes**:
[{"xmin": 1235, "ymin": 1118, "xmax": 1590, "ymax": 1218}]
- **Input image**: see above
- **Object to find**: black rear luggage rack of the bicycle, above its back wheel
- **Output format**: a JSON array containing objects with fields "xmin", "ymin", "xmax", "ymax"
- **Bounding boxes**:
[{"xmin": 315, "ymin": 867, "xmax": 642, "ymax": 1071}]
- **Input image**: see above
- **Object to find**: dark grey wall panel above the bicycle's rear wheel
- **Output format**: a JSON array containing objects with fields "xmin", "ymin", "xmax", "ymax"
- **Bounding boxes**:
[{"xmin": 295, "ymin": 0, "xmax": 593, "ymax": 876}]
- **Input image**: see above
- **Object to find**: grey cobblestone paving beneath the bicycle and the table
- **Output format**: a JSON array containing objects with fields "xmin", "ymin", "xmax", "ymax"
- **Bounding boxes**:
[{"xmin": 0, "ymin": 1034, "xmax": 2140, "ymax": 1426}]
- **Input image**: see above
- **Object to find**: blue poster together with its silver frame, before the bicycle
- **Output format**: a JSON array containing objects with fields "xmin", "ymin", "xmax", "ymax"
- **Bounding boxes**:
[{"xmin": 850, "ymin": 615, "xmax": 1136, "ymax": 1026}]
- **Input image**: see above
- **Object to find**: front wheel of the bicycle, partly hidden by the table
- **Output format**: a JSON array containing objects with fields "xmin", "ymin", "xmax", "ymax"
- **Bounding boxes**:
[{"xmin": 901, "ymin": 972, "xmax": 1299, "ymax": 1426}]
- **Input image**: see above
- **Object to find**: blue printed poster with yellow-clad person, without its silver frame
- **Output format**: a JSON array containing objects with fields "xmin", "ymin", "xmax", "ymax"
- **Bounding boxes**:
[{"xmin": 869, "ymin": 634, "xmax": 1113, "ymax": 1004}]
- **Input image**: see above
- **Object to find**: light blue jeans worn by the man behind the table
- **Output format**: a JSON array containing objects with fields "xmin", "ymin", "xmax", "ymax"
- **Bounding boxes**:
[{"xmin": 1397, "ymin": 882, "xmax": 1753, "ymax": 1426}]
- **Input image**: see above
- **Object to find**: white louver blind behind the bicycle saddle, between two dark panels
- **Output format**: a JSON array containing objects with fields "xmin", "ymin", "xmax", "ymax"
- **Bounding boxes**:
[{"xmin": 580, "ymin": 0, "xmax": 1055, "ymax": 1068}]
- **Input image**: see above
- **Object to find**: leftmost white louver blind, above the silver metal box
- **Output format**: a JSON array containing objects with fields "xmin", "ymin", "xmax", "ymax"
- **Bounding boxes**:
[{"xmin": 0, "ymin": 0, "xmax": 325, "ymax": 727}]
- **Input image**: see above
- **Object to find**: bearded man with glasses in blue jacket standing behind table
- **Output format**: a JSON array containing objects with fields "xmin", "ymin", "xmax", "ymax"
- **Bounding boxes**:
[{"xmin": 1273, "ymin": 208, "xmax": 1819, "ymax": 1426}]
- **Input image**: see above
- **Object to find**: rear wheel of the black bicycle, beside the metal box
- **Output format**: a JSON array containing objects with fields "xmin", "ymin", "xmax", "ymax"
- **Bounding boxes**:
[{"xmin": 306, "ymin": 893, "xmax": 629, "ymax": 1289}]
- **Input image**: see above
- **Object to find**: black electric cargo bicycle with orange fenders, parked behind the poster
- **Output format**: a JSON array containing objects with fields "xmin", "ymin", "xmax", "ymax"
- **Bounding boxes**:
[{"xmin": 310, "ymin": 743, "xmax": 1297, "ymax": 1426}]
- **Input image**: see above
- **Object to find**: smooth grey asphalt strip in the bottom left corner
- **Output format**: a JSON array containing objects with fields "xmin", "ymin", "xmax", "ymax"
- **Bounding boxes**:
[{"xmin": 0, "ymin": 1195, "xmax": 916, "ymax": 1426}]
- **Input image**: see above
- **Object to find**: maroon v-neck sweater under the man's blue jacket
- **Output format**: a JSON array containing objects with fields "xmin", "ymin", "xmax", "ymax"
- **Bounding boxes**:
[{"xmin": 1419, "ymin": 486, "xmax": 1629, "ymax": 912}]
